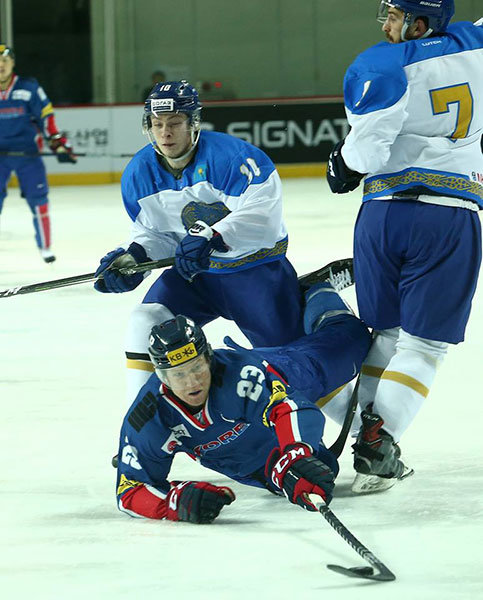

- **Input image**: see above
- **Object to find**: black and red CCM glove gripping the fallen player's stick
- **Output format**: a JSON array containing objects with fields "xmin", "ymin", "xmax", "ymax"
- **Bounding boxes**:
[{"xmin": 265, "ymin": 444, "xmax": 335, "ymax": 511}]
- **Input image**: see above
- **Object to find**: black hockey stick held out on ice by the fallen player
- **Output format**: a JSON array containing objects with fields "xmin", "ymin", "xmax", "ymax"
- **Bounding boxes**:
[{"xmin": 308, "ymin": 494, "xmax": 396, "ymax": 581}]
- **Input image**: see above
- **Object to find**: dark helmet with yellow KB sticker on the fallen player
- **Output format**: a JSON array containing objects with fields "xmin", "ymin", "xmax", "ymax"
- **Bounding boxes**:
[{"xmin": 148, "ymin": 315, "xmax": 211, "ymax": 381}]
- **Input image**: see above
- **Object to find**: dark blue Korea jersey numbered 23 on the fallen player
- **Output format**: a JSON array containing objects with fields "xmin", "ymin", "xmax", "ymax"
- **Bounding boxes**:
[{"xmin": 117, "ymin": 342, "xmax": 338, "ymax": 519}]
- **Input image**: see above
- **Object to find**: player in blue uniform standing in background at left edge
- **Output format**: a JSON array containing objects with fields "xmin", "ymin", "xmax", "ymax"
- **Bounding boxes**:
[{"xmin": 0, "ymin": 43, "xmax": 76, "ymax": 263}]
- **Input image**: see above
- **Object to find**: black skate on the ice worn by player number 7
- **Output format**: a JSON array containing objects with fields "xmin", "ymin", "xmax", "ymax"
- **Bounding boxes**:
[{"xmin": 352, "ymin": 410, "xmax": 414, "ymax": 494}]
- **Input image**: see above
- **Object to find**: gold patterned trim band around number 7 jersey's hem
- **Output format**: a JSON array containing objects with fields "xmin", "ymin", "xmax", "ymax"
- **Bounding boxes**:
[{"xmin": 364, "ymin": 170, "xmax": 483, "ymax": 200}]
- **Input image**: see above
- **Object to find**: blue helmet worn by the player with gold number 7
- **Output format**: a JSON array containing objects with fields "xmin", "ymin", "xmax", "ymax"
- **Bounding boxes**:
[{"xmin": 377, "ymin": 0, "xmax": 455, "ymax": 40}]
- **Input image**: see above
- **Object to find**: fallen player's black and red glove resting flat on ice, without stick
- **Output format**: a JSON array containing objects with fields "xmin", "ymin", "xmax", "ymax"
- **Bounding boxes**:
[{"xmin": 166, "ymin": 481, "xmax": 235, "ymax": 523}]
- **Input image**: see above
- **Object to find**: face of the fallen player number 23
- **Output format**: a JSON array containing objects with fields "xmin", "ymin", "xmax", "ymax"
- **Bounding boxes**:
[{"xmin": 163, "ymin": 354, "xmax": 211, "ymax": 406}]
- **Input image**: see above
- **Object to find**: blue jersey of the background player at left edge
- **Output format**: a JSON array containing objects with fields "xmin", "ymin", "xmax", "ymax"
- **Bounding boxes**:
[{"xmin": 0, "ymin": 75, "xmax": 54, "ymax": 153}]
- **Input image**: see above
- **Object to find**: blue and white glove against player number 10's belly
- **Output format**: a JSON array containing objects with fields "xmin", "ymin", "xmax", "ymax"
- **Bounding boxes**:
[{"xmin": 175, "ymin": 221, "xmax": 228, "ymax": 281}]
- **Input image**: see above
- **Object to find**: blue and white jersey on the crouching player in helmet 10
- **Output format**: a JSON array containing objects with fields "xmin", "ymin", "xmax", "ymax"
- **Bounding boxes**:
[{"xmin": 121, "ymin": 131, "xmax": 287, "ymax": 273}]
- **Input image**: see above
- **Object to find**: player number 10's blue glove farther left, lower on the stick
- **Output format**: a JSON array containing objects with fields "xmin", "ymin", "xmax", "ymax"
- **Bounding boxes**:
[{"xmin": 94, "ymin": 242, "xmax": 149, "ymax": 294}]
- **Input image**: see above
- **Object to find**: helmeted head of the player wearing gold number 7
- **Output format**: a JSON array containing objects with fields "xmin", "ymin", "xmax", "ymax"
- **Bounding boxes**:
[{"xmin": 377, "ymin": 0, "xmax": 454, "ymax": 42}]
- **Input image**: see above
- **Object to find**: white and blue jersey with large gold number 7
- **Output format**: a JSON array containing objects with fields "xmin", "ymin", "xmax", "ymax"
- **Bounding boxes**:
[{"xmin": 342, "ymin": 22, "xmax": 483, "ymax": 210}]
